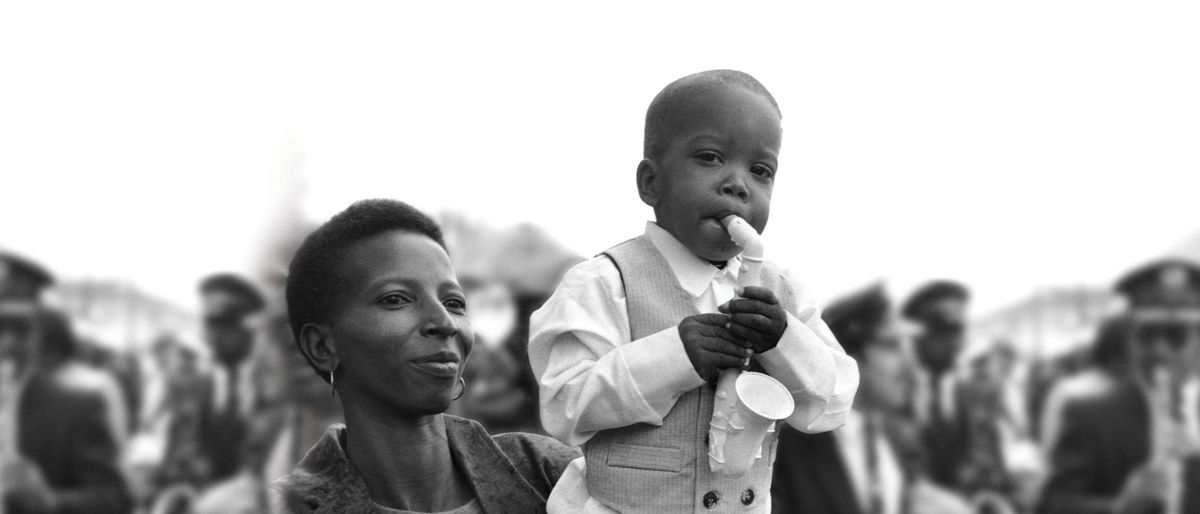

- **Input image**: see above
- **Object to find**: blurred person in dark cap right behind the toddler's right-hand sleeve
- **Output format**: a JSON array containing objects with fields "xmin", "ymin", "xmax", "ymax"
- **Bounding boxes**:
[{"xmin": 772, "ymin": 286, "xmax": 972, "ymax": 514}]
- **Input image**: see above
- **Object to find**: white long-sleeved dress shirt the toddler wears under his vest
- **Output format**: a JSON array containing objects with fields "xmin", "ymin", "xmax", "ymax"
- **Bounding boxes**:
[{"xmin": 529, "ymin": 222, "xmax": 858, "ymax": 512}]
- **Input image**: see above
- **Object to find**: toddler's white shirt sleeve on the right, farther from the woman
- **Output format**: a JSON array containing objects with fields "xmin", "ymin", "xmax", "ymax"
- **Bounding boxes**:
[{"xmin": 758, "ymin": 274, "xmax": 858, "ymax": 434}]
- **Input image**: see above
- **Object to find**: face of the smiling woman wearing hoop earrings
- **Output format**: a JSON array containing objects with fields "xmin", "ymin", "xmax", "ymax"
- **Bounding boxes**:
[{"xmin": 330, "ymin": 231, "xmax": 474, "ymax": 416}]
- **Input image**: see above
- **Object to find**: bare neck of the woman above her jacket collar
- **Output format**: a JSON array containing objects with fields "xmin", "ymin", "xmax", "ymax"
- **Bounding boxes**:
[{"xmin": 342, "ymin": 405, "xmax": 473, "ymax": 512}]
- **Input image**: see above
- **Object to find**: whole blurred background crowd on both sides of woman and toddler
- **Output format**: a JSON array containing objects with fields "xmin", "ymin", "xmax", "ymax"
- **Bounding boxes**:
[{"xmin": 0, "ymin": 230, "xmax": 1200, "ymax": 514}]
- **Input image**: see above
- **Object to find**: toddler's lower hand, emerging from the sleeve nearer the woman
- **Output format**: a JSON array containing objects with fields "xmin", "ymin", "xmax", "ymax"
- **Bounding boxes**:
[{"xmin": 679, "ymin": 312, "xmax": 750, "ymax": 381}]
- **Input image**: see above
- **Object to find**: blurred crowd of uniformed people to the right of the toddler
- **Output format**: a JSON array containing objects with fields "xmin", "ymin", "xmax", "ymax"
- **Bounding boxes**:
[{"xmin": 773, "ymin": 258, "xmax": 1200, "ymax": 514}]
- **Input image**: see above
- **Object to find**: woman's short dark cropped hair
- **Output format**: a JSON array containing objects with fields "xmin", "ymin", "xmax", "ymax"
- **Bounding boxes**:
[{"xmin": 284, "ymin": 199, "xmax": 446, "ymax": 381}]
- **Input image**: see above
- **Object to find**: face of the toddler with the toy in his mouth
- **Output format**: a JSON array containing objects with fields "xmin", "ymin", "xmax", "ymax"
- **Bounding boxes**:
[{"xmin": 652, "ymin": 86, "xmax": 781, "ymax": 262}]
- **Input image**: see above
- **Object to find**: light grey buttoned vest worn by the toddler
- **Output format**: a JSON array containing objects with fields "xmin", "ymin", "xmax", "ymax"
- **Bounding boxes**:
[{"xmin": 583, "ymin": 237, "xmax": 796, "ymax": 514}]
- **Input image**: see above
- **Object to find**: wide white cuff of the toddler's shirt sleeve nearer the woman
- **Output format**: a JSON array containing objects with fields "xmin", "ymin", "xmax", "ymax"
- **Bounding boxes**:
[{"xmin": 618, "ymin": 327, "xmax": 704, "ymax": 417}]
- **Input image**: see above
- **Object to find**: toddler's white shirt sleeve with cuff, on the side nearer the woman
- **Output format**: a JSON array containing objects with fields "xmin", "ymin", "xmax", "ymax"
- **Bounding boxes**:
[{"xmin": 529, "ymin": 257, "xmax": 704, "ymax": 446}]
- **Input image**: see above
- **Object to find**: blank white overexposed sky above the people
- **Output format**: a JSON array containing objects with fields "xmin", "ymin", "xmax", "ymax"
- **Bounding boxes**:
[{"xmin": 0, "ymin": 0, "xmax": 1200, "ymax": 312}]
